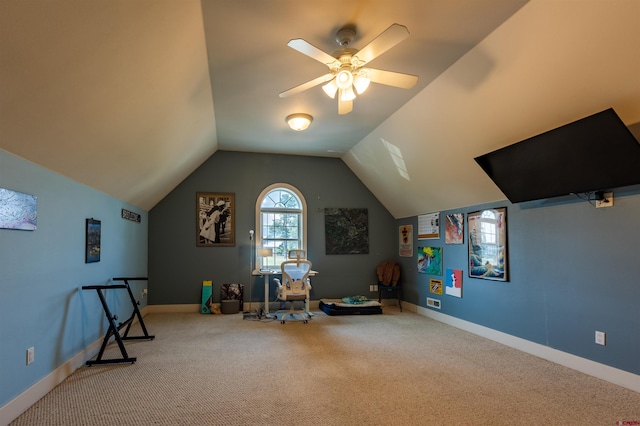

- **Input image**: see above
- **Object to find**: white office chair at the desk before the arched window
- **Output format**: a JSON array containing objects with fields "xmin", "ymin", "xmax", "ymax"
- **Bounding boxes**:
[{"xmin": 273, "ymin": 258, "xmax": 311, "ymax": 324}]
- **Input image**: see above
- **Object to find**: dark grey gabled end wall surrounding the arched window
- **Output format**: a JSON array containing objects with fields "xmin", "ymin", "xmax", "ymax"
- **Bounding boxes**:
[{"xmin": 149, "ymin": 151, "xmax": 396, "ymax": 305}]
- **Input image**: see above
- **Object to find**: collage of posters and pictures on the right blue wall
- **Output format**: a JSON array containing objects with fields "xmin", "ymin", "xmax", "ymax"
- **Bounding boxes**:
[{"xmin": 399, "ymin": 207, "xmax": 509, "ymax": 298}]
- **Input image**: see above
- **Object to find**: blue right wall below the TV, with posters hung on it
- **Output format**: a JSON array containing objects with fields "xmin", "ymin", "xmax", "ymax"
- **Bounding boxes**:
[{"xmin": 396, "ymin": 190, "xmax": 640, "ymax": 374}]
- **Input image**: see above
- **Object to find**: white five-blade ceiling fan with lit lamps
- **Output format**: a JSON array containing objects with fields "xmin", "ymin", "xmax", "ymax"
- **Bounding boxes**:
[{"xmin": 279, "ymin": 24, "xmax": 418, "ymax": 114}]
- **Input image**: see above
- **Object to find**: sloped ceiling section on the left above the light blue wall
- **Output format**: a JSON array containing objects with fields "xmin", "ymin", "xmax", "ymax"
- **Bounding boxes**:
[{"xmin": 0, "ymin": 0, "xmax": 218, "ymax": 210}]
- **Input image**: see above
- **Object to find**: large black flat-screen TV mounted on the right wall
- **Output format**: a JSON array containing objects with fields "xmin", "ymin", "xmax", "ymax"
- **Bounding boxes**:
[{"xmin": 475, "ymin": 108, "xmax": 640, "ymax": 203}]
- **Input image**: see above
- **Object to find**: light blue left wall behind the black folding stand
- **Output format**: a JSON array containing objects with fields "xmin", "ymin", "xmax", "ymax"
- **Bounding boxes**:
[{"xmin": 0, "ymin": 151, "xmax": 147, "ymax": 407}]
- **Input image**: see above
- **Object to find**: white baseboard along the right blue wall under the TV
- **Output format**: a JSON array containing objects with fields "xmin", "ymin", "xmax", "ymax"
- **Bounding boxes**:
[{"xmin": 402, "ymin": 302, "xmax": 640, "ymax": 392}]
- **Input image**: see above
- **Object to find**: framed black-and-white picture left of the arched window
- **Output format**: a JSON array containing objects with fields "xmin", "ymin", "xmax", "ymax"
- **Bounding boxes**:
[{"xmin": 196, "ymin": 192, "xmax": 236, "ymax": 247}]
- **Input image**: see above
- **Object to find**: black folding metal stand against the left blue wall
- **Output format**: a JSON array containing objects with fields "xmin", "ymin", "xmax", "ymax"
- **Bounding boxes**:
[{"xmin": 82, "ymin": 278, "xmax": 156, "ymax": 365}]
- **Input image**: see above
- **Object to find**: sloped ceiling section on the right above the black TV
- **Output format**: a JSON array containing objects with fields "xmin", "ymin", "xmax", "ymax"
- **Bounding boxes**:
[{"xmin": 343, "ymin": 0, "xmax": 640, "ymax": 218}]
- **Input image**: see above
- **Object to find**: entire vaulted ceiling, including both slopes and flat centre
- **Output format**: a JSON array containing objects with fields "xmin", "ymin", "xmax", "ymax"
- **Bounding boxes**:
[{"xmin": 0, "ymin": 0, "xmax": 640, "ymax": 218}]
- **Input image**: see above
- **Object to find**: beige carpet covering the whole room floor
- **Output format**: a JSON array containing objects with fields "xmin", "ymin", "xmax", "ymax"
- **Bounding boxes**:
[{"xmin": 12, "ymin": 307, "xmax": 640, "ymax": 426}]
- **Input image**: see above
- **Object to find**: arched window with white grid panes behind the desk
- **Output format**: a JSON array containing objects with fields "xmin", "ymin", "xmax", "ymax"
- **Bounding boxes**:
[{"xmin": 256, "ymin": 183, "xmax": 307, "ymax": 271}]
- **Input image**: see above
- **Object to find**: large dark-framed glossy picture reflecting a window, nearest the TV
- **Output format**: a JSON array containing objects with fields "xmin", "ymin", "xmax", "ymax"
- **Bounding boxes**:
[{"xmin": 467, "ymin": 207, "xmax": 509, "ymax": 281}]
